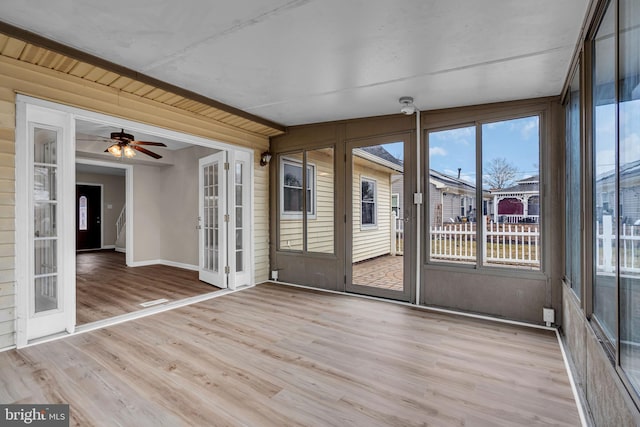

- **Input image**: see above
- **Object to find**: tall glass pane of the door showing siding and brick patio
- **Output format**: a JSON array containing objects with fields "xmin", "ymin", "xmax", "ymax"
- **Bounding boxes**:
[{"xmin": 346, "ymin": 141, "xmax": 410, "ymax": 300}]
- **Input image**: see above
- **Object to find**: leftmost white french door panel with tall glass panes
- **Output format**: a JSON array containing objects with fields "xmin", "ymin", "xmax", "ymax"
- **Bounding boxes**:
[{"xmin": 16, "ymin": 103, "xmax": 75, "ymax": 346}]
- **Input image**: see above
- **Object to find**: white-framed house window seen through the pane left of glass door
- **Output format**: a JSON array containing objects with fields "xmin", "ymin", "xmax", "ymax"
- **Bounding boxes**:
[{"xmin": 281, "ymin": 158, "xmax": 315, "ymax": 219}]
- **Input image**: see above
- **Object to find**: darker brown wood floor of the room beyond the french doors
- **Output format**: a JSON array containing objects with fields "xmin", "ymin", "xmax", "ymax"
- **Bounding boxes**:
[{"xmin": 76, "ymin": 251, "xmax": 219, "ymax": 325}]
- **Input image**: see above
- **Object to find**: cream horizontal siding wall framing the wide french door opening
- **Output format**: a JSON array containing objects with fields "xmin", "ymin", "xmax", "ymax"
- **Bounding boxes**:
[{"xmin": 0, "ymin": 56, "xmax": 269, "ymax": 348}]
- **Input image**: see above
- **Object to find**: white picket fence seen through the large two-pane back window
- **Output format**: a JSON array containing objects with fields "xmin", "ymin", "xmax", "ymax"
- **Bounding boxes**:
[{"xmin": 431, "ymin": 216, "xmax": 540, "ymax": 266}]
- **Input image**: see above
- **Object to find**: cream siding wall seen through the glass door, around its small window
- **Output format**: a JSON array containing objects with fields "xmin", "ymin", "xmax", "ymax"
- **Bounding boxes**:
[{"xmin": 352, "ymin": 158, "xmax": 391, "ymax": 263}]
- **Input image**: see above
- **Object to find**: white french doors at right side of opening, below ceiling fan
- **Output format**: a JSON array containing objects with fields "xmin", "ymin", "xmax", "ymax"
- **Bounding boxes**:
[{"xmin": 198, "ymin": 151, "xmax": 252, "ymax": 289}]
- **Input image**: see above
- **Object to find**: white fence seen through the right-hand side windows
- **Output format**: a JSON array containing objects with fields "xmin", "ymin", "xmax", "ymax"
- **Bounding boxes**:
[{"xmin": 595, "ymin": 215, "xmax": 640, "ymax": 273}]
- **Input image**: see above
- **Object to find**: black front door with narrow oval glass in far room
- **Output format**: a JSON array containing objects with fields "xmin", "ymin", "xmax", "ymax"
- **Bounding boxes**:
[{"xmin": 76, "ymin": 185, "xmax": 102, "ymax": 250}]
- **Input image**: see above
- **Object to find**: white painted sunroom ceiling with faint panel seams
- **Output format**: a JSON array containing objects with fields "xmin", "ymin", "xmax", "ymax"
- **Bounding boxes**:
[{"xmin": 0, "ymin": 0, "xmax": 589, "ymax": 125}]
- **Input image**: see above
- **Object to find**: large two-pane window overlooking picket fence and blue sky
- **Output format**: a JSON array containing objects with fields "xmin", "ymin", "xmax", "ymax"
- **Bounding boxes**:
[{"xmin": 426, "ymin": 115, "xmax": 542, "ymax": 270}]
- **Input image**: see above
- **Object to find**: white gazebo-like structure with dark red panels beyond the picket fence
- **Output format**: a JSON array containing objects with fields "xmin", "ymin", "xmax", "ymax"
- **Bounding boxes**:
[{"xmin": 491, "ymin": 175, "xmax": 540, "ymax": 223}]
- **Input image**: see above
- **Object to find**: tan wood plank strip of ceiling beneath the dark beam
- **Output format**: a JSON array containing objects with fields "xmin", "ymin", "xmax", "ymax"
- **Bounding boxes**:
[{"xmin": 0, "ymin": 34, "xmax": 284, "ymax": 137}]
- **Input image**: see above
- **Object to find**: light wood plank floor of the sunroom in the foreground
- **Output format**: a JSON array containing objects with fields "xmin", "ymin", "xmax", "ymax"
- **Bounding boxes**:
[{"xmin": 0, "ymin": 284, "xmax": 580, "ymax": 427}]
